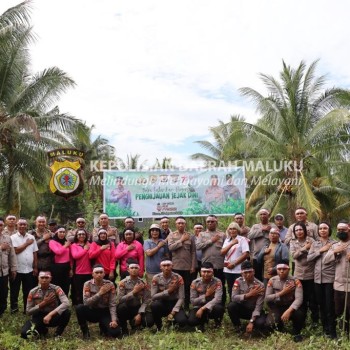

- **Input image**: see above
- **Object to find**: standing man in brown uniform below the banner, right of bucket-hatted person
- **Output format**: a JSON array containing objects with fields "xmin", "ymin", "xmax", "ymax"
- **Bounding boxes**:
[{"xmin": 168, "ymin": 216, "xmax": 197, "ymax": 309}]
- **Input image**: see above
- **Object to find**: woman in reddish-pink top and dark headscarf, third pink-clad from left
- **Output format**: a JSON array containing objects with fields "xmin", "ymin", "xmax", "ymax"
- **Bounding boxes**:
[{"xmin": 89, "ymin": 228, "xmax": 115, "ymax": 282}]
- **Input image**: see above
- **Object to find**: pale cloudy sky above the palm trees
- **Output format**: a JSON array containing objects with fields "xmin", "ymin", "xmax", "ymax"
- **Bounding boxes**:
[{"xmin": 0, "ymin": 0, "xmax": 350, "ymax": 167}]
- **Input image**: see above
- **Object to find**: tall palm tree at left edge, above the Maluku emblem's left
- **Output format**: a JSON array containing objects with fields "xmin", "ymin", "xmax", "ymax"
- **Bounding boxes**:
[{"xmin": 0, "ymin": 1, "xmax": 77, "ymax": 215}]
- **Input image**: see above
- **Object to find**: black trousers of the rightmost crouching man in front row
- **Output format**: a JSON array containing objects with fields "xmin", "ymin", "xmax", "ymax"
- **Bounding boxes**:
[{"xmin": 266, "ymin": 305, "xmax": 306, "ymax": 335}]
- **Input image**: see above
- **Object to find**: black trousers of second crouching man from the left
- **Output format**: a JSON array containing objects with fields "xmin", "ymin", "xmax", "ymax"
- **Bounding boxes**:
[{"xmin": 75, "ymin": 304, "xmax": 122, "ymax": 338}]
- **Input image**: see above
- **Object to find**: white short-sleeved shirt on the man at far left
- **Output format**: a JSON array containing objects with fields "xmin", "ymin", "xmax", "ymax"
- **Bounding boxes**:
[{"xmin": 11, "ymin": 232, "xmax": 38, "ymax": 273}]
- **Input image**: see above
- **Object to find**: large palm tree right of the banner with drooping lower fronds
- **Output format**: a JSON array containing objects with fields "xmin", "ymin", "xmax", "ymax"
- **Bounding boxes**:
[{"xmin": 196, "ymin": 61, "xmax": 350, "ymax": 218}]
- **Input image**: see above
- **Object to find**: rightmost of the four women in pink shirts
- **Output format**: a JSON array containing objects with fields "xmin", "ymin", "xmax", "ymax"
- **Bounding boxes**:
[{"xmin": 115, "ymin": 230, "xmax": 144, "ymax": 280}]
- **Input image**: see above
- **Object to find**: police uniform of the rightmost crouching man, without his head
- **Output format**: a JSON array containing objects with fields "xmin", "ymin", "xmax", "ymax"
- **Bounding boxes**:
[{"xmin": 265, "ymin": 276, "xmax": 305, "ymax": 335}]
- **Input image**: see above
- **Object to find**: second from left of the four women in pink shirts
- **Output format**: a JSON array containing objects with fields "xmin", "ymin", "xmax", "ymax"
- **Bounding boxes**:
[{"xmin": 70, "ymin": 229, "xmax": 92, "ymax": 305}]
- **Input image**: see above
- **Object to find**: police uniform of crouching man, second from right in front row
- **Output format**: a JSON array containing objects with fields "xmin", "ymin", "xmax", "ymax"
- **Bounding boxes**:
[{"xmin": 227, "ymin": 277, "xmax": 265, "ymax": 329}]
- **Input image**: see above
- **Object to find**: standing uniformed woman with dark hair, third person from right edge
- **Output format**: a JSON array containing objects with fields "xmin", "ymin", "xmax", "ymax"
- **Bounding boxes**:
[{"xmin": 290, "ymin": 221, "xmax": 319, "ymax": 324}]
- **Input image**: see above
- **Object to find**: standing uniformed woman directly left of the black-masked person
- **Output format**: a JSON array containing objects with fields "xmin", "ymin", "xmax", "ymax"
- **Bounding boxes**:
[{"xmin": 307, "ymin": 222, "xmax": 337, "ymax": 339}]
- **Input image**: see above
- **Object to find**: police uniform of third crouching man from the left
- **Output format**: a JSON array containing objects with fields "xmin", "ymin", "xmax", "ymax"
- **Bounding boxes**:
[{"xmin": 117, "ymin": 276, "xmax": 154, "ymax": 333}]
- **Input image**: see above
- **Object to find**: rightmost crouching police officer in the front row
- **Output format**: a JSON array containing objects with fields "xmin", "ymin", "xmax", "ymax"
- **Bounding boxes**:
[{"xmin": 265, "ymin": 264, "xmax": 305, "ymax": 342}]
